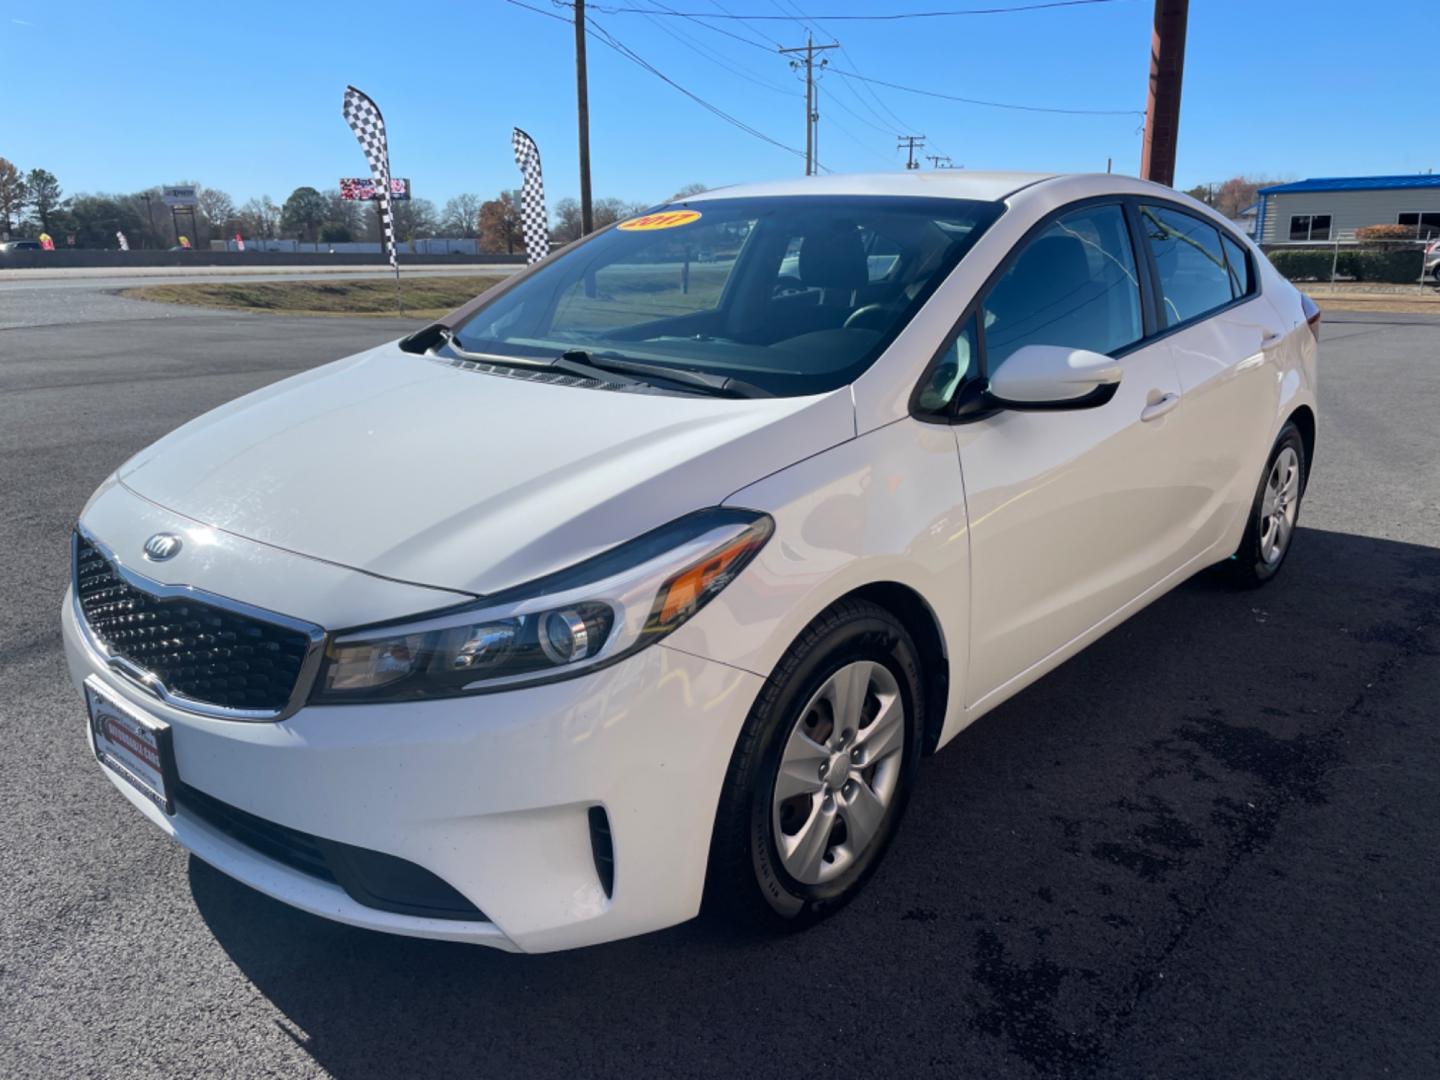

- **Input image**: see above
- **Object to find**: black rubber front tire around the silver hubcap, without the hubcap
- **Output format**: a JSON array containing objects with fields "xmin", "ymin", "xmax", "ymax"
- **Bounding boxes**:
[{"xmin": 704, "ymin": 599, "xmax": 924, "ymax": 930}]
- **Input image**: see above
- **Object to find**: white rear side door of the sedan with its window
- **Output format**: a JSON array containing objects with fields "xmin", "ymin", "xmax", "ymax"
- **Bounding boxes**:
[{"xmin": 1139, "ymin": 203, "xmax": 1286, "ymax": 567}]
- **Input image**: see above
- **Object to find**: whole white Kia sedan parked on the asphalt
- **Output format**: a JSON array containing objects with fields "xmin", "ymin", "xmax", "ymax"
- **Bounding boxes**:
[{"xmin": 63, "ymin": 171, "xmax": 1319, "ymax": 952}]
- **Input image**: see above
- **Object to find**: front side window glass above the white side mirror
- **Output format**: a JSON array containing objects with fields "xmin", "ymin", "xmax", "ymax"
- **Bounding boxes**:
[{"xmin": 982, "ymin": 204, "xmax": 1143, "ymax": 376}]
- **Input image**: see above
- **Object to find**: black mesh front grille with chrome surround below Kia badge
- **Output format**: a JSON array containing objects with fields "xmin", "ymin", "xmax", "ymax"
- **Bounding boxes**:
[{"xmin": 75, "ymin": 533, "xmax": 310, "ymax": 713}]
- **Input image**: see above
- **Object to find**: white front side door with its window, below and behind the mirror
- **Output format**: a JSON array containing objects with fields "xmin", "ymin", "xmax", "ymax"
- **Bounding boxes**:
[{"xmin": 942, "ymin": 200, "xmax": 1187, "ymax": 706}]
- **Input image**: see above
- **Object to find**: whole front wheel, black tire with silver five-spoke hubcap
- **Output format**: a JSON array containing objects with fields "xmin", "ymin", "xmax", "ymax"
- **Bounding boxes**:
[{"xmin": 706, "ymin": 600, "xmax": 924, "ymax": 929}]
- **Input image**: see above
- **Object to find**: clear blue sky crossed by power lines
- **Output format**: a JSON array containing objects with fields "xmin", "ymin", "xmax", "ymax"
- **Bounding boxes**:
[{"xmin": 0, "ymin": 0, "xmax": 1440, "ymax": 203}]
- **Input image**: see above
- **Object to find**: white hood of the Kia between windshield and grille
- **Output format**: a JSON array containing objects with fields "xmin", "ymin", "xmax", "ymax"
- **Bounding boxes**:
[{"xmin": 120, "ymin": 344, "xmax": 854, "ymax": 595}]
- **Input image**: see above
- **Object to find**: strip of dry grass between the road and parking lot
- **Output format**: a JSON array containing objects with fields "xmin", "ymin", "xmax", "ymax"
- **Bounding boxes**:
[{"xmin": 120, "ymin": 276, "xmax": 504, "ymax": 318}]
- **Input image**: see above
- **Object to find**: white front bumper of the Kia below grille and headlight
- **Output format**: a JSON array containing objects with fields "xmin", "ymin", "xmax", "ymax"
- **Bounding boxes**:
[{"xmin": 62, "ymin": 593, "xmax": 762, "ymax": 952}]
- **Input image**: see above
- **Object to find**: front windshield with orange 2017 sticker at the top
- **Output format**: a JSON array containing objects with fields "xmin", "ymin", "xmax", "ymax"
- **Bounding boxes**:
[{"xmin": 455, "ymin": 196, "xmax": 1001, "ymax": 396}]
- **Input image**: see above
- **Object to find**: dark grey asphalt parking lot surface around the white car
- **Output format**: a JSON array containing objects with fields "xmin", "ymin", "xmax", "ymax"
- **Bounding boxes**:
[{"xmin": 0, "ymin": 288, "xmax": 1440, "ymax": 1077}]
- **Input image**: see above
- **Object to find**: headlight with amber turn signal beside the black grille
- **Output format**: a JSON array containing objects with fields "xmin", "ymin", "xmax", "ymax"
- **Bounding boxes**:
[{"xmin": 310, "ymin": 508, "xmax": 775, "ymax": 704}]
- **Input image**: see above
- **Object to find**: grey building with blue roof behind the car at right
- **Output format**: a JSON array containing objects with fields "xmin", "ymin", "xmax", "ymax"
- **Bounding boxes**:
[{"xmin": 1256, "ymin": 173, "xmax": 1440, "ymax": 245}]
